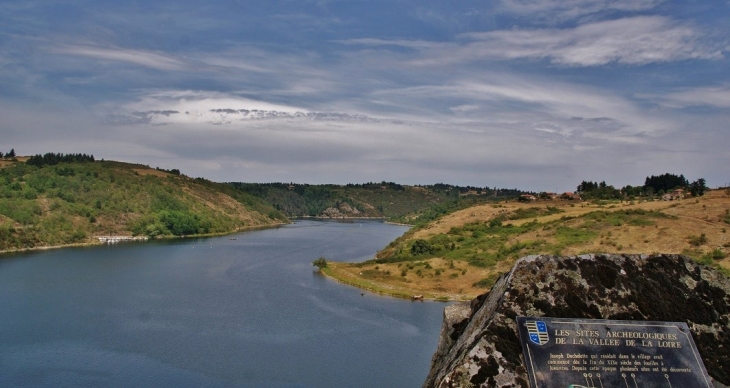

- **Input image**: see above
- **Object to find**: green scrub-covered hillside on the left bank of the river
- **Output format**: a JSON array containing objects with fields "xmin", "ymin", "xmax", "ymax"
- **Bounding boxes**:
[{"xmin": 0, "ymin": 157, "xmax": 286, "ymax": 251}]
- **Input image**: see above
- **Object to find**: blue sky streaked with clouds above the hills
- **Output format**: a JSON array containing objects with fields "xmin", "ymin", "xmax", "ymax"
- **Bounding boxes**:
[{"xmin": 0, "ymin": 0, "xmax": 730, "ymax": 192}]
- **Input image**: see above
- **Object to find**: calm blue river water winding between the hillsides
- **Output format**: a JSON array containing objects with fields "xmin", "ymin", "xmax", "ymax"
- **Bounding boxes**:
[{"xmin": 0, "ymin": 221, "xmax": 445, "ymax": 387}]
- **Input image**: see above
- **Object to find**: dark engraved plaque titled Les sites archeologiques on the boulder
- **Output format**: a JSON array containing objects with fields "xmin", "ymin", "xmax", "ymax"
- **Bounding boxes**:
[{"xmin": 517, "ymin": 317, "xmax": 713, "ymax": 388}]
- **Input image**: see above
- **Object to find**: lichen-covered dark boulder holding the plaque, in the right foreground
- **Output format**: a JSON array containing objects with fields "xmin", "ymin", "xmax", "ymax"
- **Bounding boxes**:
[{"xmin": 423, "ymin": 255, "xmax": 730, "ymax": 388}]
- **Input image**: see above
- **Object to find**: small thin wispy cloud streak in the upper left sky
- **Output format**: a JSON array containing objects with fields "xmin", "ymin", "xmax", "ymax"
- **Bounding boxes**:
[{"xmin": 52, "ymin": 45, "xmax": 189, "ymax": 70}]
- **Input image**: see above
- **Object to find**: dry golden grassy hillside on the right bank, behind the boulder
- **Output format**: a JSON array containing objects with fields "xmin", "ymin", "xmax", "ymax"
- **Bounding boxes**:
[{"xmin": 325, "ymin": 190, "xmax": 730, "ymax": 300}]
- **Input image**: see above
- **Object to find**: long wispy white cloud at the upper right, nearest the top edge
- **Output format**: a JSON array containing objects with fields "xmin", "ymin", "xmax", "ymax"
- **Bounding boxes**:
[{"xmin": 346, "ymin": 16, "xmax": 723, "ymax": 67}]
